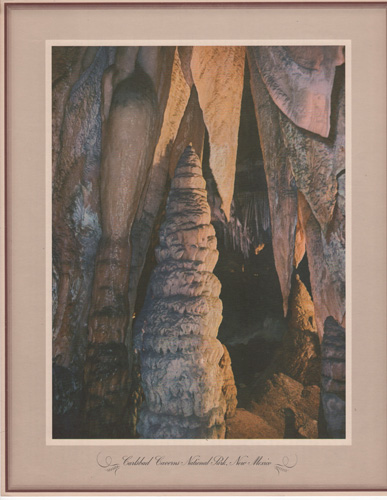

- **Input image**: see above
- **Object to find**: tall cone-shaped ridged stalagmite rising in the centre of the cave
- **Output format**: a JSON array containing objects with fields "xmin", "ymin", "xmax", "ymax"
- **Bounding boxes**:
[{"xmin": 136, "ymin": 146, "xmax": 236, "ymax": 439}]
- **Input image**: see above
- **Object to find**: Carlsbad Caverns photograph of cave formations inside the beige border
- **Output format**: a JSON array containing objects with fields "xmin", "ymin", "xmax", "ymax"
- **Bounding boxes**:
[{"xmin": 50, "ymin": 44, "xmax": 346, "ymax": 440}]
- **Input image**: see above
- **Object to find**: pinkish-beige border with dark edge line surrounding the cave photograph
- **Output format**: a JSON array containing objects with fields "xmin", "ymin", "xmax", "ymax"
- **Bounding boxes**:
[{"xmin": 2, "ymin": 1, "xmax": 387, "ymax": 496}]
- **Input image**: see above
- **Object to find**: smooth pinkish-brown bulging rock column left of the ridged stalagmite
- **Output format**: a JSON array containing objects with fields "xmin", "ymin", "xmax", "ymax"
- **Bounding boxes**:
[{"xmin": 83, "ymin": 47, "xmax": 173, "ymax": 437}]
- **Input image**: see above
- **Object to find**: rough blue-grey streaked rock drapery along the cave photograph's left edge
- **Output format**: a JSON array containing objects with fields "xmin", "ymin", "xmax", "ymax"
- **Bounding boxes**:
[{"xmin": 52, "ymin": 47, "xmax": 114, "ymax": 367}]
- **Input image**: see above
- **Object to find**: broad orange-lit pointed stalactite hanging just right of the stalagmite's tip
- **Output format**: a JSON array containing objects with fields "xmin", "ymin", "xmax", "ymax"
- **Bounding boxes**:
[{"xmin": 191, "ymin": 46, "xmax": 245, "ymax": 218}]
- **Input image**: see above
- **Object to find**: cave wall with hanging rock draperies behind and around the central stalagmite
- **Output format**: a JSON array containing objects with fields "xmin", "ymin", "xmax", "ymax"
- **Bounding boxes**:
[{"xmin": 52, "ymin": 47, "xmax": 345, "ymax": 437}]
